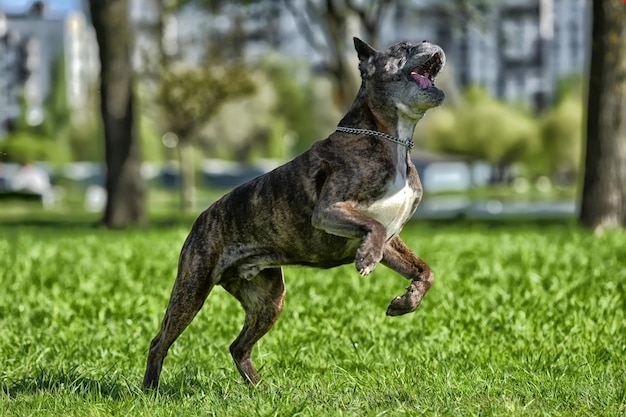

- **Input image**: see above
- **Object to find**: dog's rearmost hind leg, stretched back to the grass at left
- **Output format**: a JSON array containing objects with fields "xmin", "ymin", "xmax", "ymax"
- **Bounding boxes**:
[{"xmin": 143, "ymin": 242, "xmax": 214, "ymax": 388}]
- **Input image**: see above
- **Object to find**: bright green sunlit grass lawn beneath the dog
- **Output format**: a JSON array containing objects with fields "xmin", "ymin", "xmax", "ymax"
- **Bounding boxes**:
[{"xmin": 0, "ymin": 219, "xmax": 626, "ymax": 416}]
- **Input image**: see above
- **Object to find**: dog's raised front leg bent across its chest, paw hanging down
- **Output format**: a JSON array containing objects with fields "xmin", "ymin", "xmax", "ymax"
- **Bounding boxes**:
[{"xmin": 311, "ymin": 202, "xmax": 387, "ymax": 276}]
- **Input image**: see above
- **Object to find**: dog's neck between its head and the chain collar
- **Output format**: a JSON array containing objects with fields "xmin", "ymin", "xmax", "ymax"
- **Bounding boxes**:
[{"xmin": 339, "ymin": 86, "xmax": 424, "ymax": 147}]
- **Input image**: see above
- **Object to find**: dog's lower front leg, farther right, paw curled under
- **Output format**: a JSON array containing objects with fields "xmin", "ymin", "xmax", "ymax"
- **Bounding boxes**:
[{"xmin": 382, "ymin": 236, "xmax": 434, "ymax": 316}]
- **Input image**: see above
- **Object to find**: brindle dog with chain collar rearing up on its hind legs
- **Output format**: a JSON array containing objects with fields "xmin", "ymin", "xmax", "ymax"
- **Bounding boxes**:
[{"xmin": 143, "ymin": 38, "xmax": 445, "ymax": 388}]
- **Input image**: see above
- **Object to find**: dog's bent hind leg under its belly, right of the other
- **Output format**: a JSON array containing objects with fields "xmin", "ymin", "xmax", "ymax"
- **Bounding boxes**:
[{"xmin": 222, "ymin": 268, "xmax": 285, "ymax": 386}]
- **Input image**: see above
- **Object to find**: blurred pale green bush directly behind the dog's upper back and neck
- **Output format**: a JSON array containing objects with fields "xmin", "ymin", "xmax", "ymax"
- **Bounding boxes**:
[{"xmin": 196, "ymin": 54, "xmax": 341, "ymax": 163}]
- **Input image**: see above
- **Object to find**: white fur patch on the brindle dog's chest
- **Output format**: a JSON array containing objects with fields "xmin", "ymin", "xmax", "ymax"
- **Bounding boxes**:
[{"xmin": 363, "ymin": 173, "xmax": 421, "ymax": 239}]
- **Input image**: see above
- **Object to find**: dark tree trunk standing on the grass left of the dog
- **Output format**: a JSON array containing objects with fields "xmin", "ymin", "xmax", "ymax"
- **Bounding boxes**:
[{"xmin": 90, "ymin": 0, "xmax": 147, "ymax": 228}]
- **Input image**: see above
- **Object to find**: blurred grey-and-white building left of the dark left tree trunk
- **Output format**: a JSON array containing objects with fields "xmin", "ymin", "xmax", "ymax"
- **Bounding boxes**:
[{"xmin": 0, "ymin": 1, "xmax": 98, "ymax": 140}]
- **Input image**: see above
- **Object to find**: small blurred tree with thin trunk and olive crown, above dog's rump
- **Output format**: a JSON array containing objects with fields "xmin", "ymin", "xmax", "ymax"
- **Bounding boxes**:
[{"xmin": 157, "ymin": 64, "xmax": 255, "ymax": 211}]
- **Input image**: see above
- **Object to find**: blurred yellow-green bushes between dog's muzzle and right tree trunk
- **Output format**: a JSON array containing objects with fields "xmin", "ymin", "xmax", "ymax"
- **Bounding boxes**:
[{"xmin": 416, "ymin": 77, "xmax": 584, "ymax": 181}]
